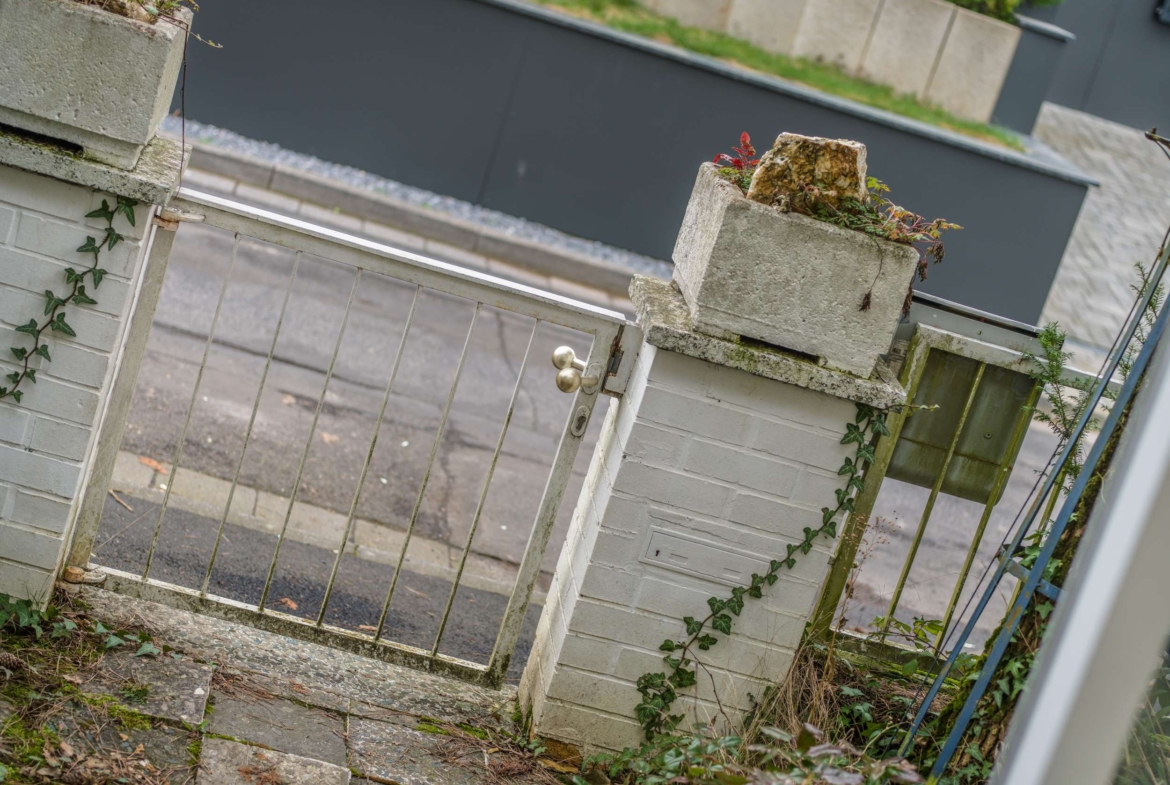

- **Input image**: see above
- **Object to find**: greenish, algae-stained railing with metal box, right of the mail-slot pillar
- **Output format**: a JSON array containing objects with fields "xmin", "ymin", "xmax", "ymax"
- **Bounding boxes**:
[{"xmin": 810, "ymin": 311, "xmax": 1086, "ymax": 645}]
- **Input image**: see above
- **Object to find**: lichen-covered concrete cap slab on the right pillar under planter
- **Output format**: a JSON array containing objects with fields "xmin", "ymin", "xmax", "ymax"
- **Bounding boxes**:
[{"xmin": 629, "ymin": 275, "xmax": 906, "ymax": 409}]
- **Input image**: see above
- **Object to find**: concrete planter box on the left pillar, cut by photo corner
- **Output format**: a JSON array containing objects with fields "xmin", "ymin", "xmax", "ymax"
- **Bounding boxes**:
[{"xmin": 0, "ymin": 0, "xmax": 191, "ymax": 168}]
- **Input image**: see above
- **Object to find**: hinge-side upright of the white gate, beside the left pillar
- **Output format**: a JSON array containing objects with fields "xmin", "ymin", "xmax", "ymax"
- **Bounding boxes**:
[{"xmin": 66, "ymin": 216, "xmax": 178, "ymax": 567}]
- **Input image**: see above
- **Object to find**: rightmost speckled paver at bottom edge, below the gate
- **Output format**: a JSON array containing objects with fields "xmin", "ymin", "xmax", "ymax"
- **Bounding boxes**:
[{"xmin": 349, "ymin": 717, "xmax": 480, "ymax": 785}]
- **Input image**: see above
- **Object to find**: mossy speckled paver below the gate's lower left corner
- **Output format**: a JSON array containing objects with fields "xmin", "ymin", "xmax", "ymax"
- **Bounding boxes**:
[{"xmin": 84, "ymin": 652, "xmax": 212, "ymax": 725}]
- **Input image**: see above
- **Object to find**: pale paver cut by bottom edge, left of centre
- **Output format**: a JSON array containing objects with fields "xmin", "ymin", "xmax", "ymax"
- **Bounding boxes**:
[{"xmin": 195, "ymin": 738, "xmax": 351, "ymax": 785}]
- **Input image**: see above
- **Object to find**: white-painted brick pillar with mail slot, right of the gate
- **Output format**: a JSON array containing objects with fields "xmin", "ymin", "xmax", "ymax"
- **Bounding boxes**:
[{"xmin": 521, "ymin": 344, "xmax": 855, "ymax": 750}]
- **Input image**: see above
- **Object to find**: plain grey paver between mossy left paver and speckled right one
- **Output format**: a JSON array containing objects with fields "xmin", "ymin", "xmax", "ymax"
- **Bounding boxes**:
[{"xmin": 208, "ymin": 695, "xmax": 345, "ymax": 766}]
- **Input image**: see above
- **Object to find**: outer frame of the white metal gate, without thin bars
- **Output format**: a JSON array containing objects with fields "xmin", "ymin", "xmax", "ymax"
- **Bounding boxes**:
[{"xmin": 67, "ymin": 188, "xmax": 642, "ymax": 688}]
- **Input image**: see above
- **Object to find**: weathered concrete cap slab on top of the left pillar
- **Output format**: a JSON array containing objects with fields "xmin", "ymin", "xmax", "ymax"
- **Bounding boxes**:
[{"xmin": 0, "ymin": 130, "xmax": 191, "ymax": 205}]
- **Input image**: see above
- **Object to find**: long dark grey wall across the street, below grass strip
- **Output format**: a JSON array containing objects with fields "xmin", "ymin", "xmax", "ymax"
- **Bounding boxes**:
[{"xmin": 177, "ymin": 0, "xmax": 1086, "ymax": 322}]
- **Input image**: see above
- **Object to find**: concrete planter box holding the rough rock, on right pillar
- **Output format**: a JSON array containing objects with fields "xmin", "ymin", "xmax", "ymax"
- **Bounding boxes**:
[{"xmin": 674, "ymin": 164, "xmax": 918, "ymax": 378}]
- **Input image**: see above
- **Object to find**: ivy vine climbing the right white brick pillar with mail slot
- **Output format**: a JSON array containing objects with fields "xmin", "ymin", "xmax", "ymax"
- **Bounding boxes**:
[{"xmin": 634, "ymin": 404, "xmax": 889, "ymax": 741}]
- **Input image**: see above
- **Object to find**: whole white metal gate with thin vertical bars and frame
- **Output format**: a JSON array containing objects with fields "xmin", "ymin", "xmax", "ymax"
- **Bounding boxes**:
[{"xmin": 69, "ymin": 188, "xmax": 641, "ymax": 686}]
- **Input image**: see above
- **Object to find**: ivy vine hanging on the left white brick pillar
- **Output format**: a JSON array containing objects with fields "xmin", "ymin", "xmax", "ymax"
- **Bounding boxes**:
[{"xmin": 0, "ymin": 197, "xmax": 138, "ymax": 404}]
